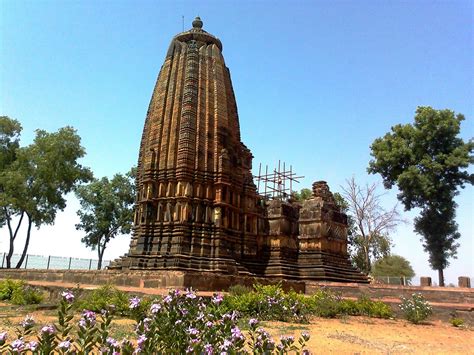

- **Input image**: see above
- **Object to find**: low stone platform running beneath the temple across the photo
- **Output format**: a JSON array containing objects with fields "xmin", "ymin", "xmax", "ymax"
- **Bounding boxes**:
[{"xmin": 0, "ymin": 269, "xmax": 474, "ymax": 325}]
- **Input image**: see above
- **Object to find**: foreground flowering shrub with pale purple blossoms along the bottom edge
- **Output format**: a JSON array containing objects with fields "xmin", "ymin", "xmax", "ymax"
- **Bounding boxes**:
[{"xmin": 0, "ymin": 290, "xmax": 309, "ymax": 355}]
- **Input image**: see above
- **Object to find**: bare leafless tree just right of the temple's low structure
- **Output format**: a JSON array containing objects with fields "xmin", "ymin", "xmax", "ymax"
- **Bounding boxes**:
[{"xmin": 336, "ymin": 178, "xmax": 403, "ymax": 274}]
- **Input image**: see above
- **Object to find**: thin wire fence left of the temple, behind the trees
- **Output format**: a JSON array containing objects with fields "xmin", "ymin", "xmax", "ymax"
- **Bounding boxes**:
[{"xmin": 1, "ymin": 253, "xmax": 110, "ymax": 270}]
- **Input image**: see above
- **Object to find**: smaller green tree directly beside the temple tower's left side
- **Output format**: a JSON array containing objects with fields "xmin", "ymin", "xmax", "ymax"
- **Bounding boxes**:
[{"xmin": 76, "ymin": 169, "xmax": 136, "ymax": 270}]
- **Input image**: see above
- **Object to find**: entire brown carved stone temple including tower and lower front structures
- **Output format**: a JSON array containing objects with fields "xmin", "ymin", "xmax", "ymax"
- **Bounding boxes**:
[{"xmin": 110, "ymin": 17, "xmax": 367, "ymax": 282}]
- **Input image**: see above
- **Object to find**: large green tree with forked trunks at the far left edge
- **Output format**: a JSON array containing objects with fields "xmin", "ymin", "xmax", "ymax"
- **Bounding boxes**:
[{"xmin": 0, "ymin": 117, "xmax": 91, "ymax": 268}]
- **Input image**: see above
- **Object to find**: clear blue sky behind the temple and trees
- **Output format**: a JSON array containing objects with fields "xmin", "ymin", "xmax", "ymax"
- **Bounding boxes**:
[{"xmin": 0, "ymin": 0, "xmax": 474, "ymax": 283}]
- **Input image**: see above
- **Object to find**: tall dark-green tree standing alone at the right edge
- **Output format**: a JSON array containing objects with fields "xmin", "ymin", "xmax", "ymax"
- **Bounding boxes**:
[{"xmin": 368, "ymin": 107, "xmax": 474, "ymax": 286}]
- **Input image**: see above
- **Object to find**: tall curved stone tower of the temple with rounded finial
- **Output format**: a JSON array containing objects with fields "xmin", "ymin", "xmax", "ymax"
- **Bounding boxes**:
[{"xmin": 111, "ymin": 17, "xmax": 264, "ymax": 273}]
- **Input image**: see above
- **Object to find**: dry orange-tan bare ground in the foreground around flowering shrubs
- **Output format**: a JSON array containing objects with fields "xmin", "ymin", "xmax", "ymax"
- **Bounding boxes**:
[{"xmin": 0, "ymin": 303, "xmax": 474, "ymax": 354}]
